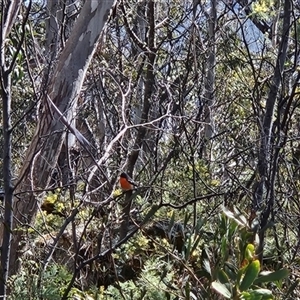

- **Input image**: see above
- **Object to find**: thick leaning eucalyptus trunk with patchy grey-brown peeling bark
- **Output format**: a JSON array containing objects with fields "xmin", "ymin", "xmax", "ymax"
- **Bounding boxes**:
[{"xmin": 5, "ymin": 0, "xmax": 114, "ymax": 274}]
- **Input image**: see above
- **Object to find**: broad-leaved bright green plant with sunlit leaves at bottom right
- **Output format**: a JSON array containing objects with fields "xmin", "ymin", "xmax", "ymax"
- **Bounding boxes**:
[{"xmin": 212, "ymin": 209, "xmax": 289, "ymax": 299}]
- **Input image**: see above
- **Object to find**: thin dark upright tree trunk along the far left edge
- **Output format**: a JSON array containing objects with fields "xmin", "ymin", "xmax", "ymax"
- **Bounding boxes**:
[{"xmin": 0, "ymin": 1, "xmax": 24, "ymax": 299}]
